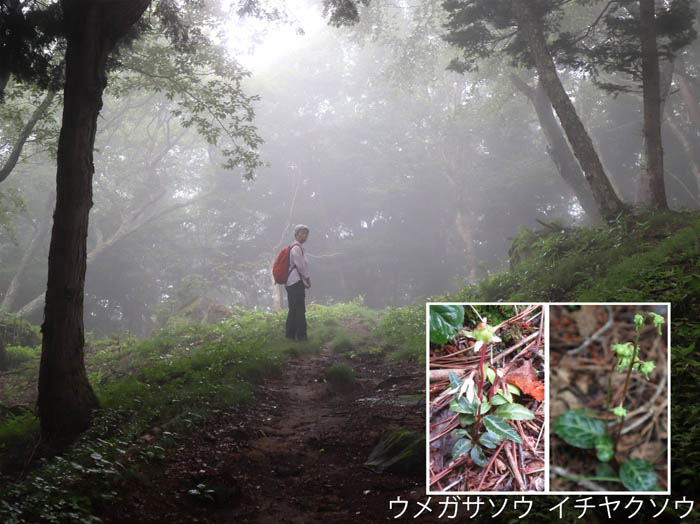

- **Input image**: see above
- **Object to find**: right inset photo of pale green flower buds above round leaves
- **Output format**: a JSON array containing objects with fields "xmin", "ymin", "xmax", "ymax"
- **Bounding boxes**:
[{"xmin": 549, "ymin": 304, "xmax": 670, "ymax": 494}]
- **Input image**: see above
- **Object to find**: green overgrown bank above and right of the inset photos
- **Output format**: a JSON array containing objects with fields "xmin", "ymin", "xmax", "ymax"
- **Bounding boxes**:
[{"xmin": 448, "ymin": 212, "xmax": 700, "ymax": 521}]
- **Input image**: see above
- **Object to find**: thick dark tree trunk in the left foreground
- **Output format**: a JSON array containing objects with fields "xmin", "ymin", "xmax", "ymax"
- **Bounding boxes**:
[{"xmin": 38, "ymin": 0, "xmax": 149, "ymax": 445}]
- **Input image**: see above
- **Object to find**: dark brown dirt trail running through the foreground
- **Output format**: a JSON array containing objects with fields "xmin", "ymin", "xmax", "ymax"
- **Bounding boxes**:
[{"xmin": 101, "ymin": 350, "xmax": 425, "ymax": 524}]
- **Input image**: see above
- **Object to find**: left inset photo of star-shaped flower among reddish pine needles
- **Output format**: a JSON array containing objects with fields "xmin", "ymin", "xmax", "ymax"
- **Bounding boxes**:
[{"xmin": 426, "ymin": 304, "xmax": 547, "ymax": 494}]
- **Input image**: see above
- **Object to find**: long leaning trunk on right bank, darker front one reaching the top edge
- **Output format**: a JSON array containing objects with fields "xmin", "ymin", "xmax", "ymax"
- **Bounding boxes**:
[{"xmin": 514, "ymin": 1, "xmax": 624, "ymax": 219}]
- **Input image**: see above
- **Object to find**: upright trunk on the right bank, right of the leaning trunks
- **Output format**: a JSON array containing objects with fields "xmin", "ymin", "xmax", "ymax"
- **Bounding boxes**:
[{"xmin": 639, "ymin": 0, "xmax": 668, "ymax": 209}]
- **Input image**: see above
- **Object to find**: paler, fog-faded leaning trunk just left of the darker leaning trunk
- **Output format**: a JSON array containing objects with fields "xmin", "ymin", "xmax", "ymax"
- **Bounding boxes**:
[{"xmin": 510, "ymin": 74, "xmax": 601, "ymax": 224}]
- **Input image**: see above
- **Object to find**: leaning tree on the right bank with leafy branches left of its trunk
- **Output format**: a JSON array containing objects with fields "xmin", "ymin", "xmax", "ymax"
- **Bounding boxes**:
[{"xmin": 443, "ymin": 0, "xmax": 623, "ymax": 218}]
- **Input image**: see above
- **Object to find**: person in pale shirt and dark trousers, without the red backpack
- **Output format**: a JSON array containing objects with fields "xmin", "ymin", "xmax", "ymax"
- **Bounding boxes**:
[{"xmin": 285, "ymin": 224, "xmax": 311, "ymax": 340}]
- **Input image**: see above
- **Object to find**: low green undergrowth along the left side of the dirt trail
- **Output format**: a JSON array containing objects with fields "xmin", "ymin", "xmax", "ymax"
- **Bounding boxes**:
[{"xmin": 0, "ymin": 298, "xmax": 423, "ymax": 523}]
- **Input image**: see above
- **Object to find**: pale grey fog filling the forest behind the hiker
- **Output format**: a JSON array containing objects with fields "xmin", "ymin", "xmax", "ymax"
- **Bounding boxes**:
[{"xmin": 0, "ymin": 2, "xmax": 700, "ymax": 334}]
